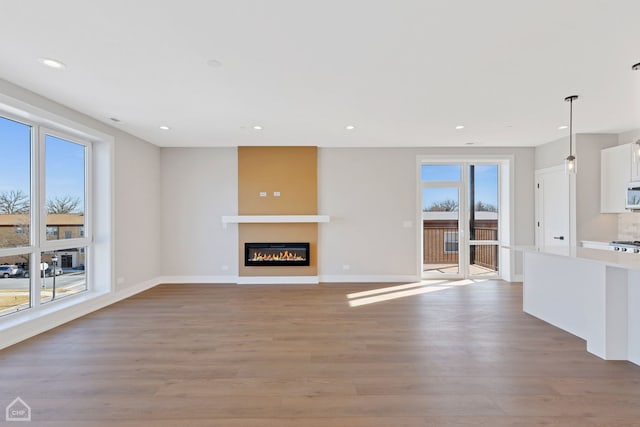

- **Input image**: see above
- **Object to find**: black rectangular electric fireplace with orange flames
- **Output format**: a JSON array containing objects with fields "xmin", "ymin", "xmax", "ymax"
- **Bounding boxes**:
[{"xmin": 244, "ymin": 243, "xmax": 310, "ymax": 267}]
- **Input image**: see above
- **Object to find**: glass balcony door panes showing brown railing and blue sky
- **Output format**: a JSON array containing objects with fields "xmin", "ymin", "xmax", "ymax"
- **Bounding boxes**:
[{"xmin": 420, "ymin": 162, "xmax": 499, "ymax": 278}]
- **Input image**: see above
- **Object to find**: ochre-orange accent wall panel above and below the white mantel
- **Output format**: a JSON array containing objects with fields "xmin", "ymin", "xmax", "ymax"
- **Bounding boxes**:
[{"xmin": 238, "ymin": 147, "xmax": 318, "ymax": 276}]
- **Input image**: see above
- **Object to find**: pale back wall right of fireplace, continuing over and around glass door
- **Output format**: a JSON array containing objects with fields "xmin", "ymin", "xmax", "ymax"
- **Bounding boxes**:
[{"xmin": 318, "ymin": 148, "xmax": 534, "ymax": 280}]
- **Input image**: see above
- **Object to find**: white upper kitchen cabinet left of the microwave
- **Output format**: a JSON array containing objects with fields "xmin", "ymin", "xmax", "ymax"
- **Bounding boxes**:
[{"xmin": 600, "ymin": 144, "xmax": 637, "ymax": 213}]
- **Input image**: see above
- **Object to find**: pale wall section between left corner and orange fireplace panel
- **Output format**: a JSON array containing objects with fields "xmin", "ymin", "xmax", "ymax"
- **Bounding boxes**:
[{"xmin": 160, "ymin": 148, "xmax": 238, "ymax": 282}]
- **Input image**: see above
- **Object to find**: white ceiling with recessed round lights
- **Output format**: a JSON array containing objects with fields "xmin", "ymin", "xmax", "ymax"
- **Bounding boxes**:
[{"xmin": 0, "ymin": 0, "xmax": 640, "ymax": 147}]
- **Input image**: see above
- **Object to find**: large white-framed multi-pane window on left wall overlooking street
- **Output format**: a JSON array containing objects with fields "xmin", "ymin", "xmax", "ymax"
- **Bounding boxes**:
[{"xmin": 0, "ymin": 116, "xmax": 91, "ymax": 316}]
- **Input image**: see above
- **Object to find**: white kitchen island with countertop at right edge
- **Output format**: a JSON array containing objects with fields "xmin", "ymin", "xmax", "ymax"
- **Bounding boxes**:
[{"xmin": 511, "ymin": 247, "xmax": 640, "ymax": 365}]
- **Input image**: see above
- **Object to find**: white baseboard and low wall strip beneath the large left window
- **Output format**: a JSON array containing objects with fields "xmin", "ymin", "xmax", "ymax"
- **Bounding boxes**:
[{"xmin": 0, "ymin": 278, "xmax": 161, "ymax": 349}]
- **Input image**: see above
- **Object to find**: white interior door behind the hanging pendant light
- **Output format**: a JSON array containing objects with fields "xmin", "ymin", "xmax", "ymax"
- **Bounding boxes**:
[{"xmin": 536, "ymin": 167, "xmax": 573, "ymax": 255}]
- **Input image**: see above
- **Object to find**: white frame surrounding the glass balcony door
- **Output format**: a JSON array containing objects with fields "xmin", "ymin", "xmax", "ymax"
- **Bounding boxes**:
[{"xmin": 415, "ymin": 154, "xmax": 518, "ymax": 281}]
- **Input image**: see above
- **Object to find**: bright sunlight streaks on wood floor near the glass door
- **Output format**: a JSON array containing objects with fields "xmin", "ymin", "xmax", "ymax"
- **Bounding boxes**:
[{"xmin": 347, "ymin": 279, "xmax": 484, "ymax": 307}]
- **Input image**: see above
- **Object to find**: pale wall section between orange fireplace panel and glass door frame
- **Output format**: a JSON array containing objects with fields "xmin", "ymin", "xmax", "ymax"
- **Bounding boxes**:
[{"xmin": 318, "ymin": 148, "xmax": 418, "ymax": 281}]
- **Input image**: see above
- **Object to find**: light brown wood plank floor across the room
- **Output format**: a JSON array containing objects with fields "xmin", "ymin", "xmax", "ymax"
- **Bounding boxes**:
[{"xmin": 0, "ymin": 282, "xmax": 640, "ymax": 427}]
